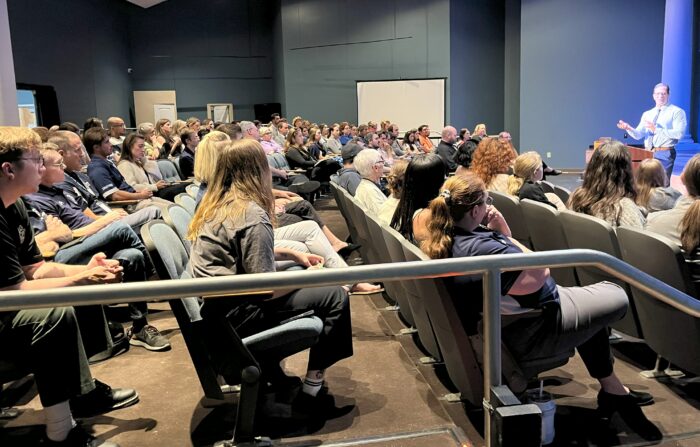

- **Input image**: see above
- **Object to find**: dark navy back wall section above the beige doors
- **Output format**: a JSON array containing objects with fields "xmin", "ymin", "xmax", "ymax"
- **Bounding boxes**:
[{"xmin": 129, "ymin": 0, "xmax": 277, "ymax": 120}]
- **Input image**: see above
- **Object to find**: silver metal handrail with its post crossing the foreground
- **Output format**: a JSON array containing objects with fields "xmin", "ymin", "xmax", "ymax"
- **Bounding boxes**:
[{"xmin": 0, "ymin": 249, "xmax": 700, "ymax": 445}]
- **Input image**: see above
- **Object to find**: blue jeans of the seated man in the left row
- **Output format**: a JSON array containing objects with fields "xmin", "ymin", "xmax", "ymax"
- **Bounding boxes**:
[{"xmin": 54, "ymin": 221, "xmax": 151, "ymax": 324}]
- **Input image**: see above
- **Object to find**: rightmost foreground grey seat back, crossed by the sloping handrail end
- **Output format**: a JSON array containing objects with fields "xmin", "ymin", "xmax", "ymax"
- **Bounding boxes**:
[{"xmin": 617, "ymin": 226, "xmax": 700, "ymax": 374}]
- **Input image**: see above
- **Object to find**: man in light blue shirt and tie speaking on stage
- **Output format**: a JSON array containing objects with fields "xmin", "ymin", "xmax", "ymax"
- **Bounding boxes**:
[{"xmin": 617, "ymin": 82, "xmax": 688, "ymax": 181}]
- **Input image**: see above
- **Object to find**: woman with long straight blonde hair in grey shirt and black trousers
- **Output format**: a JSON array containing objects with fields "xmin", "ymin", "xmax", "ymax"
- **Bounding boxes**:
[{"xmin": 188, "ymin": 139, "xmax": 352, "ymax": 402}]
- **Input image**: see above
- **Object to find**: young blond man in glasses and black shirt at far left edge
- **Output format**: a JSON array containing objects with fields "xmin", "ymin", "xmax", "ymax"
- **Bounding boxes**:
[{"xmin": 0, "ymin": 127, "xmax": 138, "ymax": 447}]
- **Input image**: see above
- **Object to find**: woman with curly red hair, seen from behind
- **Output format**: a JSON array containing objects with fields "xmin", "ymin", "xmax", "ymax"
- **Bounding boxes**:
[{"xmin": 471, "ymin": 138, "xmax": 518, "ymax": 194}]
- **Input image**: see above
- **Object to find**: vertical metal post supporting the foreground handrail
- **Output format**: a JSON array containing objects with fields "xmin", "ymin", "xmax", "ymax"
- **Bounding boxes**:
[{"xmin": 483, "ymin": 268, "xmax": 501, "ymax": 447}]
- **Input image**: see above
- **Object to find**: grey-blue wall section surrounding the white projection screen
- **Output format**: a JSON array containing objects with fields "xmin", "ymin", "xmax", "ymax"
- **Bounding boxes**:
[{"xmin": 281, "ymin": 0, "xmax": 450, "ymax": 123}]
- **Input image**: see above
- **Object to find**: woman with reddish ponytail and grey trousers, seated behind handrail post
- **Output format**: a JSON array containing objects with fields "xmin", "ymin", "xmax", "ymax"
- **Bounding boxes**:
[{"xmin": 421, "ymin": 174, "xmax": 653, "ymax": 417}]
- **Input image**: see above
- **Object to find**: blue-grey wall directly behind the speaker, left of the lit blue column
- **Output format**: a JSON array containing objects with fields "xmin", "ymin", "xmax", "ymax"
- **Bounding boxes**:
[{"xmin": 519, "ymin": 0, "xmax": 665, "ymax": 168}]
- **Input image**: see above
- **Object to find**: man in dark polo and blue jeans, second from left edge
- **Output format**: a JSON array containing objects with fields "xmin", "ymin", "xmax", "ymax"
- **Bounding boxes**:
[{"xmin": 25, "ymin": 149, "xmax": 170, "ymax": 351}]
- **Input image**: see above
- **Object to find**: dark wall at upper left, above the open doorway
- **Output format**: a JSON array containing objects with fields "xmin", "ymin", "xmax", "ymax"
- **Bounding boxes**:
[{"xmin": 7, "ymin": 0, "xmax": 131, "ymax": 125}]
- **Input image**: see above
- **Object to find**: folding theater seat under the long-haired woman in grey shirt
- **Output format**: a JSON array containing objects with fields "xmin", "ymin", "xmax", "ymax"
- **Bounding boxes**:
[{"xmin": 141, "ymin": 220, "xmax": 323, "ymax": 445}]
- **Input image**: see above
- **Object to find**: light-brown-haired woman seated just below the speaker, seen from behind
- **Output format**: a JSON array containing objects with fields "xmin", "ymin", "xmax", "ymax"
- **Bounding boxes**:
[{"xmin": 634, "ymin": 158, "xmax": 682, "ymax": 213}]
